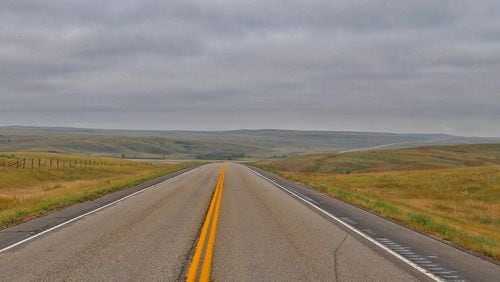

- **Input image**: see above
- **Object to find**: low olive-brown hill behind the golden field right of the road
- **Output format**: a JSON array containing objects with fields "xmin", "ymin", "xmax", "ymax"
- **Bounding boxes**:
[{"xmin": 258, "ymin": 143, "xmax": 500, "ymax": 173}]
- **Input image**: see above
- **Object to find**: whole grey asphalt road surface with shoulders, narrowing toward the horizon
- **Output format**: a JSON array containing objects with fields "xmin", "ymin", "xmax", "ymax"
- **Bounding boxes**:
[{"xmin": 0, "ymin": 164, "xmax": 500, "ymax": 281}]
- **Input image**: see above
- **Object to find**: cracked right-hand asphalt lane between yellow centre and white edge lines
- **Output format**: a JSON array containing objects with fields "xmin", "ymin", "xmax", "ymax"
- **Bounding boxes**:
[{"xmin": 212, "ymin": 164, "xmax": 422, "ymax": 281}]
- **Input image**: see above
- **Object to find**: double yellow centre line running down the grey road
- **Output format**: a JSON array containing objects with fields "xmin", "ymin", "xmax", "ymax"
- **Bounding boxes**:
[{"xmin": 186, "ymin": 164, "xmax": 227, "ymax": 282}]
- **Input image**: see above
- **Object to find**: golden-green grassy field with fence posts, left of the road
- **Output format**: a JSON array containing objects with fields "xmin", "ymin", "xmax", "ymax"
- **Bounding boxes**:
[{"xmin": 0, "ymin": 152, "xmax": 195, "ymax": 228}]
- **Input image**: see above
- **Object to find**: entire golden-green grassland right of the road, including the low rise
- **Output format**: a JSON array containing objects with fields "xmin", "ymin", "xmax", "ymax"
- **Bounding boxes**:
[{"xmin": 258, "ymin": 145, "xmax": 500, "ymax": 260}]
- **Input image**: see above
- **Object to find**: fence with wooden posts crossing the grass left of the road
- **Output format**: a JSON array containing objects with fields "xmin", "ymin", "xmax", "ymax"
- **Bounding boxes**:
[{"xmin": 0, "ymin": 158, "xmax": 158, "ymax": 169}]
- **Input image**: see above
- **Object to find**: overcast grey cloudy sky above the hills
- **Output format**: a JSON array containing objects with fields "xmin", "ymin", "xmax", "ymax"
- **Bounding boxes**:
[{"xmin": 0, "ymin": 0, "xmax": 500, "ymax": 136}]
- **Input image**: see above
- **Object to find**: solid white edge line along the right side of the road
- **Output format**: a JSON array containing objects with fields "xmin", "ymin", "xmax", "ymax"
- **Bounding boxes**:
[{"xmin": 248, "ymin": 167, "xmax": 444, "ymax": 281}]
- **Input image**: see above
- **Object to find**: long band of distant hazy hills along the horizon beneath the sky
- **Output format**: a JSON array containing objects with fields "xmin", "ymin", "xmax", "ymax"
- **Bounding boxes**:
[{"xmin": 0, "ymin": 126, "xmax": 500, "ymax": 159}]
